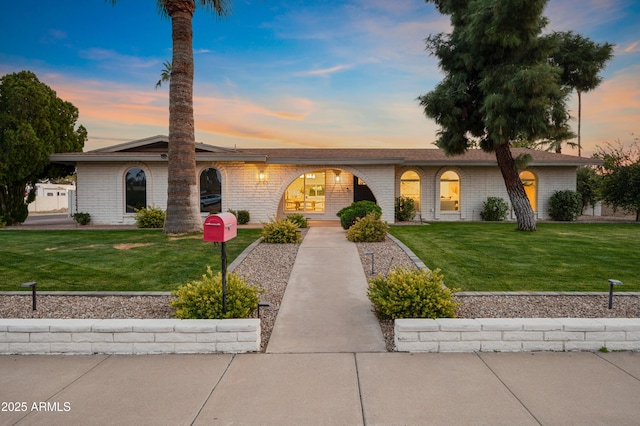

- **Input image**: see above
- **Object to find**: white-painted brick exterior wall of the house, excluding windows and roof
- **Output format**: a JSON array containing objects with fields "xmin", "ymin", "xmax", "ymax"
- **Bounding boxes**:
[{"xmin": 77, "ymin": 162, "xmax": 576, "ymax": 224}]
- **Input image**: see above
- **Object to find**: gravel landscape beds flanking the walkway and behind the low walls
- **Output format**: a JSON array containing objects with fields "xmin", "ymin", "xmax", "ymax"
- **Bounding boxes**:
[{"xmin": 0, "ymin": 231, "xmax": 640, "ymax": 351}]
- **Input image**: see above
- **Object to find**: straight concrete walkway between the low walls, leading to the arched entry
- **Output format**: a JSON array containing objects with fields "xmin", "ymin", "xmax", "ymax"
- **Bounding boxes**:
[{"xmin": 266, "ymin": 227, "xmax": 386, "ymax": 353}]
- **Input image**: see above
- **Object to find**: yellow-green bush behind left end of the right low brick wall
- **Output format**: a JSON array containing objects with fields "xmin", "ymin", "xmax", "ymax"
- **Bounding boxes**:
[{"xmin": 367, "ymin": 267, "xmax": 458, "ymax": 319}]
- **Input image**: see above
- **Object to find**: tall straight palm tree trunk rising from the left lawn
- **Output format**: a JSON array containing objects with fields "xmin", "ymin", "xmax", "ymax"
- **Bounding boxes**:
[{"xmin": 164, "ymin": 0, "xmax": 202, "ymax": 234}]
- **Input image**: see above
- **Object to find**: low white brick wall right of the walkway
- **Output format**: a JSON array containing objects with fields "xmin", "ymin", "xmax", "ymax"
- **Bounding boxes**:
[{"xmin": 394, "ymin": 318, "xmax": 640, "ymax": 352}]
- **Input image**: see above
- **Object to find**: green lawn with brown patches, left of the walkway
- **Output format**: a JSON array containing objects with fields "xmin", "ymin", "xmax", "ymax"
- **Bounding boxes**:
[{"xmin": 0, "ymin": 229, "xmax": 261, "ymax": 291}]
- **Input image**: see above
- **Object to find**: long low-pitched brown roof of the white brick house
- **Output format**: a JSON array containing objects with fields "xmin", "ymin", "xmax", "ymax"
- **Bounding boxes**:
[{"xmin": 50, "ymin": 135, "xmax": 600, "ymax": 166}]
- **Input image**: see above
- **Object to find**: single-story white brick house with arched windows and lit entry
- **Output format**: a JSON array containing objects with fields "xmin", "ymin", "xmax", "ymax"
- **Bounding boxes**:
[{"xmin": 51, "ymin": 136, "xmax": 593, "ymax": 224}]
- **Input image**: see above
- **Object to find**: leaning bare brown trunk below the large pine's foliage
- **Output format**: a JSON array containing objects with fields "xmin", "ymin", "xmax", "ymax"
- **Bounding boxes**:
[{"xmin": 496, "ymin": 144, "xmax": 536, "ymax": 231}]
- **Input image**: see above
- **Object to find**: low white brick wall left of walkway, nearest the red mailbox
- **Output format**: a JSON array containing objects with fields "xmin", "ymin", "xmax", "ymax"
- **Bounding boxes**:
[{"xmin": 0, "ymin": 318, "xmax": 260, "ymax": 355}]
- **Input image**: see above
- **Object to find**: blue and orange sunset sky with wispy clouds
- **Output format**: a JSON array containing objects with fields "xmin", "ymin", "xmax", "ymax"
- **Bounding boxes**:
[{"xmin": 0, "ymin": 0, "xmax": 640, "ymax": 155}]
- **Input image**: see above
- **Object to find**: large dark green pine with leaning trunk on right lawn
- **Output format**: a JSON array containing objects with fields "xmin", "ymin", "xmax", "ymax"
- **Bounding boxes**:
[{"xmin": 419, "ymin": 0, "xmax": 566, "ymax": 231}]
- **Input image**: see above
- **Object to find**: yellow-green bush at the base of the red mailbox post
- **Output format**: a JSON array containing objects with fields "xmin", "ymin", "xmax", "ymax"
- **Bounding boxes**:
[{"xmin": 171, "ymin": 267, "xmax": 262, "ymax": 319}]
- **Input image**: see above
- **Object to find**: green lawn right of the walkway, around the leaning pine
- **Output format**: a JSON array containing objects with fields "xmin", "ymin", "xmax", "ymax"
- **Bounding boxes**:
[{"xmin": 390, "ymin": 222, "xmax": 640, "ymax": 292}]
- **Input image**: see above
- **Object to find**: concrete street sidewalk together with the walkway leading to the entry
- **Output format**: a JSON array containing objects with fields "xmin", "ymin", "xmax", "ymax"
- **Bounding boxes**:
[{"xmin": 0, "ymin": 227, "xmax": 640, "ymax": 426}]
